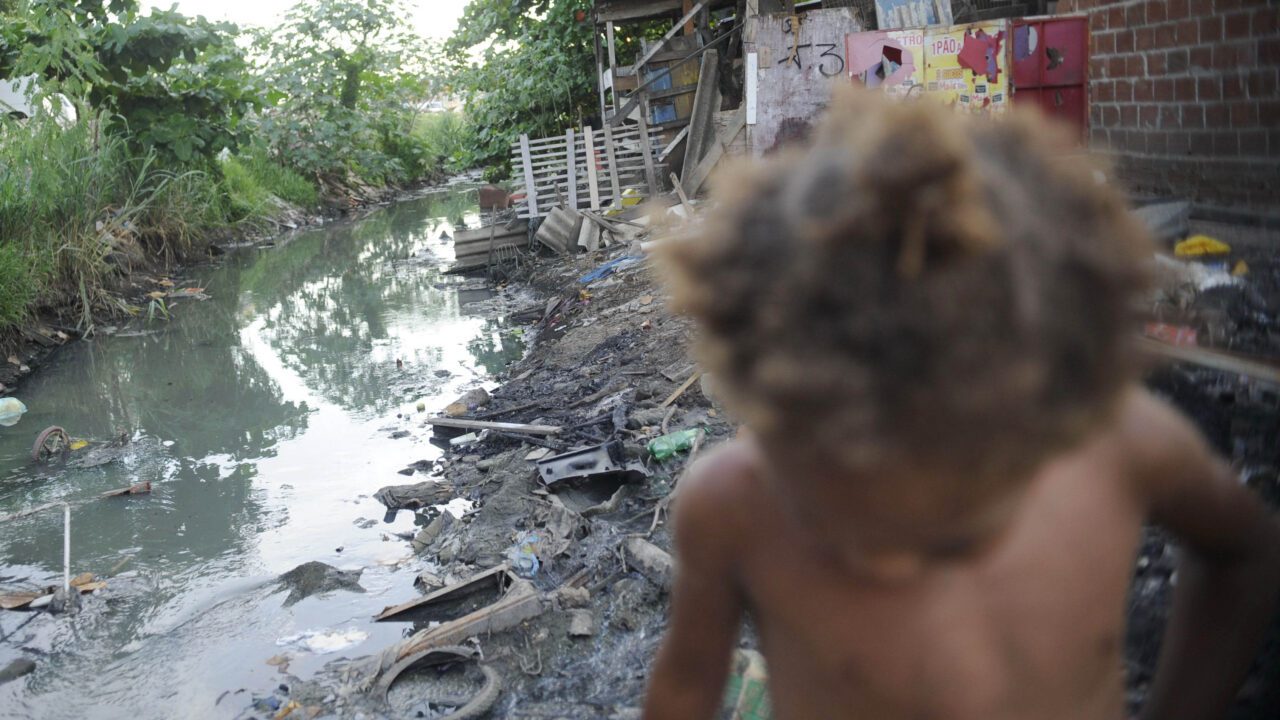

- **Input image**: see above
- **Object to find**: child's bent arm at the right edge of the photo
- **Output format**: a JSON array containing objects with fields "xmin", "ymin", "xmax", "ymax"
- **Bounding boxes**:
[{"xmin": 1134, "ymin": 396, "xmax": 1280, "ymax": 720}]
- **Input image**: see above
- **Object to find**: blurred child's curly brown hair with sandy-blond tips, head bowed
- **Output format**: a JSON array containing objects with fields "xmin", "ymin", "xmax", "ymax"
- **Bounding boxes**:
[{"xmin": 662, "ymin": 91, "xmax": 1151, "ymax": 500}]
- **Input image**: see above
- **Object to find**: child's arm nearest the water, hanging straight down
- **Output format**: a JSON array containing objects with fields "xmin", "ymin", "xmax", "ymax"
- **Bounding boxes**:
[{"xmin": 644, "ymin": 454, "xmax": 742, "ymax": 720}]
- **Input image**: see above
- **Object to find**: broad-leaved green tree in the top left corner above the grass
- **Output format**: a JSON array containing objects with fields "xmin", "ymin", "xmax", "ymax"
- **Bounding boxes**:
[{"xmin": 0, "ymin": 0, "xmax": 261, "ymax": 163}]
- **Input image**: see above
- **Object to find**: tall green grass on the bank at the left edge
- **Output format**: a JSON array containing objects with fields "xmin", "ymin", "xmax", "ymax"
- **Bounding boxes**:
[{"xmin": 0, "ymin": 117, "xmax": 225, "ymax": 331}]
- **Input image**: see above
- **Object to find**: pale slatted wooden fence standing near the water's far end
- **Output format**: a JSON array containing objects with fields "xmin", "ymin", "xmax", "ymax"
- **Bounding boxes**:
[{"xmin": 511, "ymin": 123, "xmax": 663, "ymax": 218}]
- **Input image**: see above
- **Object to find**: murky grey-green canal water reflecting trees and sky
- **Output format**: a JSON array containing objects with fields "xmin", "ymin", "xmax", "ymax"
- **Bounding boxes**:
[{"xmin": 0, "ymin": 185, "xmax": 522, "ymax": 719}]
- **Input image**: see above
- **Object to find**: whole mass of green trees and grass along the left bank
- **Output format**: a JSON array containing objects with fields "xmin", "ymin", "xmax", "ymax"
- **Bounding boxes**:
[{"xmin": 0, "ymin": 0, "xmax": 455, "ymax": 341}]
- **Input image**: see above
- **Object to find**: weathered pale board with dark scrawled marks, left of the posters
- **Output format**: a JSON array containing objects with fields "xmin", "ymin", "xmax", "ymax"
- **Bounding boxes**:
[{"xmin": 744, "ymin": 8, "xmax": 863, "ymax": 155}]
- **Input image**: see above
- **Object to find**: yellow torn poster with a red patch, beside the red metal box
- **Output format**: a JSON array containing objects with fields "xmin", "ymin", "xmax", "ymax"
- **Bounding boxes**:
[{"xmin": 924, "ymin": 20, "xmax": 1009, "ymax": 113}]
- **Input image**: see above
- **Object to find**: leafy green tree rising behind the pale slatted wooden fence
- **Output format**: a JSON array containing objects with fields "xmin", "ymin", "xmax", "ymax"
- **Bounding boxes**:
[{"xmin": 447, "ymin": 0, "xmax": 598, "ymax": 168}]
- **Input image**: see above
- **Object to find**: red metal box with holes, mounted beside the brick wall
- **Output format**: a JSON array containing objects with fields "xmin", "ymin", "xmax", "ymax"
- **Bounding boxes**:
[{"xmin": 1011, "ymin": 17, "xmax": 1089, "ymax": 140}]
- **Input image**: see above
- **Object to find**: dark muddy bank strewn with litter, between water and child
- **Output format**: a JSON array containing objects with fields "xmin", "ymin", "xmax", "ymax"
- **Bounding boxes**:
[{"xmin": 259, "ymin": 221, "xmax": 1280, "ymax": 720}]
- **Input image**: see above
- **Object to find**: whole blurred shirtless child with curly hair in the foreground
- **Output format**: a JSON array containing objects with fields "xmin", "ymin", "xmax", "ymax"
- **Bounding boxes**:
[{"xmin": 645, "ymin": 88, "xmax": 1280, "ymax": 720}]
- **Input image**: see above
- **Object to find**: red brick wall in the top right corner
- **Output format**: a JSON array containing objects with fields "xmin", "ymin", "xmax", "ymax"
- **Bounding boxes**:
[{"xmin": 1057, "ymin": 0, "xmax": 1280, "ymax": 214}]
